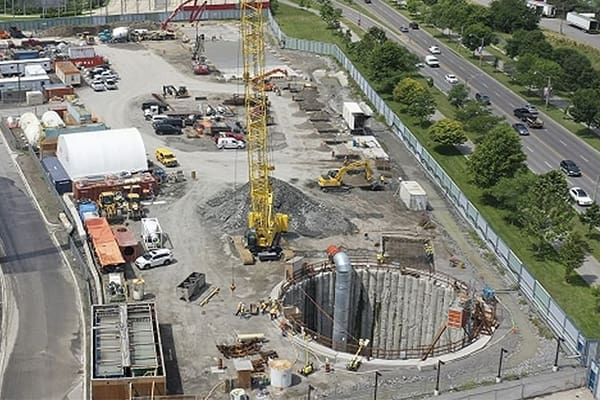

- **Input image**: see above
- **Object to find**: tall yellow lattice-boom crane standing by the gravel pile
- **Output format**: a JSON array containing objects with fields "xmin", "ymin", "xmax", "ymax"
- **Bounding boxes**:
[{"xmin": 240, "ymin": 0, "xmax": 288, "ymax": 261}]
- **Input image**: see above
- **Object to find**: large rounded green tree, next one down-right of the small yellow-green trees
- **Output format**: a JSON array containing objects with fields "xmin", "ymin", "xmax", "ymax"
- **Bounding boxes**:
[{"xmin": 468, "ymin": 124, "xmax": 527, "ymax": 188}]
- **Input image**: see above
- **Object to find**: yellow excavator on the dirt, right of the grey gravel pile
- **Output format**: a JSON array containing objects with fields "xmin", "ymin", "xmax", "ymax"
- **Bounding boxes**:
[{"xmin": 318, "ymin": 160, "xmax": 383, "ymax": 192}]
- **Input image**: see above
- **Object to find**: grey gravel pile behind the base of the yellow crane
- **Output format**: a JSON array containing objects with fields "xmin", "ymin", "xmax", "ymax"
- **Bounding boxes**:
[{"xmin": 198, "ymin": 179, "xmax": 356, "ymax": 238}]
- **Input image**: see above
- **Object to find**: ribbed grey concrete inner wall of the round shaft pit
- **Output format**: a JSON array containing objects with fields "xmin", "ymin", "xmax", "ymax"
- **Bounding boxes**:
[{"xmin": 284, "ymin": 267, "xmax": 467, "ymax": 359}]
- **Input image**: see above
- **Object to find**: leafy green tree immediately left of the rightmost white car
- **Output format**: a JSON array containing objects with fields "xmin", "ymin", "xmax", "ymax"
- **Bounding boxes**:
[{"xmin": 519, "ymin": 170, "xmax": 575, "ymax": 256}]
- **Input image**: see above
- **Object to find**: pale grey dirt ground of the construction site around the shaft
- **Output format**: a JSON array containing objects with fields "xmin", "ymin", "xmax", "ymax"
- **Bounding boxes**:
[{"xmin": 2, "ymin": 23, "xmax": 576, "ymax": 399}]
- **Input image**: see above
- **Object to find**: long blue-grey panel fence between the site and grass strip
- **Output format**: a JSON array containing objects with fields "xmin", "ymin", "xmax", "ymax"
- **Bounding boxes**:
[{"xmin": 269, "ymin": 10, "xmax": 600, "ymax": 399}]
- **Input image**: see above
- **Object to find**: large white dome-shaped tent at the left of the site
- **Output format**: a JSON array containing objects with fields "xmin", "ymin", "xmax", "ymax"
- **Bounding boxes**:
[{"xmin": 56, "ymin": 128, "xmax": 148, "ymax": 180}]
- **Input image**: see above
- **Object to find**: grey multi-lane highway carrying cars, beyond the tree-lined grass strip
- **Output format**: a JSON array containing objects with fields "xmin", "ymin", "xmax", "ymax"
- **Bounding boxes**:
[{"xmin": 336, "ymin": 0, "xmax": 600, "ymax": 198}]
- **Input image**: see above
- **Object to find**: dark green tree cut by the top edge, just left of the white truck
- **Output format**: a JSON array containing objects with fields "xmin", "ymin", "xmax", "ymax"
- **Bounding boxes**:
[{"xmin": 490, "ymin": 0, "xmax": 540, "ymax": 33}]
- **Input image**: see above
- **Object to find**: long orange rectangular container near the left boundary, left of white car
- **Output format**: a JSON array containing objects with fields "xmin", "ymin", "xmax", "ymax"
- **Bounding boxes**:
[{"xmin": 85, "ymin": 218, "xmax": 125, "ymax": 273}]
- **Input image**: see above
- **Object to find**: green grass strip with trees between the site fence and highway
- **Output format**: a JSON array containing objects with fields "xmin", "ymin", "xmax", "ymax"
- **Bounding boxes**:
[{"xmin": 276, "ymin": 4, "xmax": 600, "ymax": 337}]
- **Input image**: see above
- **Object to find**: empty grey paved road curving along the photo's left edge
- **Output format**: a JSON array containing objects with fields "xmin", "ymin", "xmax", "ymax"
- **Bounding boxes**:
[{"xmin": 0, "ymin": 139, "xmax": 82, "ymax": 400}]
